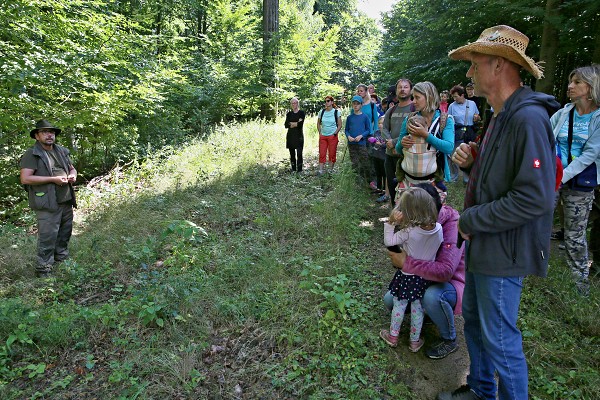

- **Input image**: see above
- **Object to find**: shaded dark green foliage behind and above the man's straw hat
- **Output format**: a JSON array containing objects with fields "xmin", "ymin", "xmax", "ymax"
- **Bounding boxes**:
[{"xmin": 377, "ymin": 0, "xmax": 599, "ymax": 96}]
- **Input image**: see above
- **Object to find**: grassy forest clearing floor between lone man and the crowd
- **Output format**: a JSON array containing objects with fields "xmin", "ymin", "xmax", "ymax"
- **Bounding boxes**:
[{"xmin": 0, "ymin": 116, "xmax": 600, "ymax": 399}]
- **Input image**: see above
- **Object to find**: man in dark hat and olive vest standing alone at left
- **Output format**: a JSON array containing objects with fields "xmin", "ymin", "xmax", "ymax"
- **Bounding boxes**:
[{"xmin": 21, "ymin": 120, "xmax": 77, "ymax": 278}]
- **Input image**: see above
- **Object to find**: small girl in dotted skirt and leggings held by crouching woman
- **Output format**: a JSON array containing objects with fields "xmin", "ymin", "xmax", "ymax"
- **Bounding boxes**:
[{"xmin": 379, "ymin": 187, "xmax": 443, "ymax": 352}]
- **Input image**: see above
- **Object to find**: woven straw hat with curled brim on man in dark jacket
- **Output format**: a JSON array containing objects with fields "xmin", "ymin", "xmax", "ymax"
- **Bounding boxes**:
[{"xmin": 448, "ymin": 25, "xmax": 544, "ymax": 79}]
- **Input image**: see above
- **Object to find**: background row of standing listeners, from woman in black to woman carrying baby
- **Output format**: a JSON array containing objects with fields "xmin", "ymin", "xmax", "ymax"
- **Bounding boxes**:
[{"xmin": 285, "ymin": 78, "xmax": 488, "ymax": 206}]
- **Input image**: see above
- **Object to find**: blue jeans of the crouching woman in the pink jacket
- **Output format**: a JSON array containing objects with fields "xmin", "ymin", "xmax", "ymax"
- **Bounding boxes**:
[{"xmin": 383, "ymin": 282, "xmax": 456, "ymax": 340}]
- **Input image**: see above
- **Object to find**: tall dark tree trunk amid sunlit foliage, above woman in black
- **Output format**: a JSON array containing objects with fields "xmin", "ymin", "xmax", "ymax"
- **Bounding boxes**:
[{"xmin": 260, "ymin": 0, "xmax": 279, "ymax": 120}]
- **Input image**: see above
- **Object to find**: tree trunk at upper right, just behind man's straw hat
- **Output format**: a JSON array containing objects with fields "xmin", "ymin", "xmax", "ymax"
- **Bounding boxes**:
[{"xmin": 535, "ymin": 0, "xmax": 561, "ymax": 94}]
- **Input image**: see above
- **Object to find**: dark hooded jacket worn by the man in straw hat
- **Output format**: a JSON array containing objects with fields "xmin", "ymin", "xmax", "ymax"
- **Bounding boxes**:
[{"xmin": 459, "ymin": 87, "xmax": 560, "ymax": 276}]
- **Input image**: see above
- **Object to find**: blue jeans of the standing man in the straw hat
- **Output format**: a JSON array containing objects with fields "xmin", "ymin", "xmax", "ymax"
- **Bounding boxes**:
[{"xmin": 463, "ymin": 272, "xmax": 527, "ymax": 400}]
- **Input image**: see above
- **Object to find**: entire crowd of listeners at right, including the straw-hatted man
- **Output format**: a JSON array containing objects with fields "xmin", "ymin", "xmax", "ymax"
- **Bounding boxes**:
[{"xmin": 282, "ymin": 25, "xmax": 600, "ymax": 400}]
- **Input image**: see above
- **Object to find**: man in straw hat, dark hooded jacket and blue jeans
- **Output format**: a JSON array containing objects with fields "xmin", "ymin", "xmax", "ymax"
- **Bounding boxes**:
[{"xmin": 438, "ymin": 25, "xmax": 560, "ymax": 400}]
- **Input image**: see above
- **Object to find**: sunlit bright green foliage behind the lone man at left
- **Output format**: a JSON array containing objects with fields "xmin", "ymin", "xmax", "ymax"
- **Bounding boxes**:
[{"xmin": 0, "ymin": 0, "xmax": 370, "ymax": 216}]
